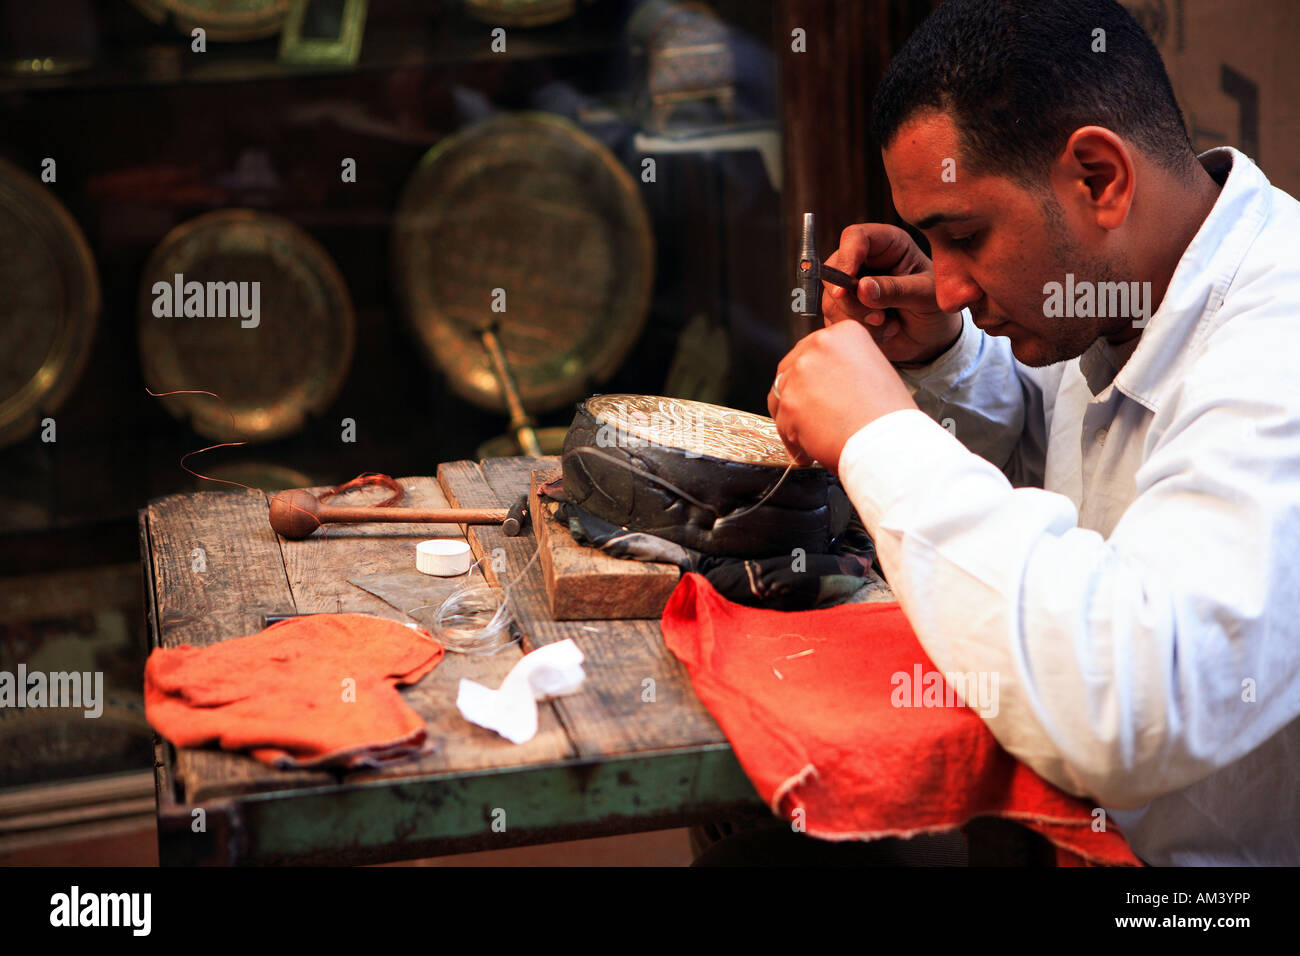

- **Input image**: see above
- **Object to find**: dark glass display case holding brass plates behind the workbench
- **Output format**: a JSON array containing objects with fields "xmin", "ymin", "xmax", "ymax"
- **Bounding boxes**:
[{"xmin": 0, "ymin": 0, "xmax": 789, "ymax": 538}]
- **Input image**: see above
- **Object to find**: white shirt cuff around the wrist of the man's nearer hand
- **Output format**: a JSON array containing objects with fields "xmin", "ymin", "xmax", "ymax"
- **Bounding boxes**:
[{"xmin": 839, "ymin": 408, "xmax": 978, "ymax": 537}]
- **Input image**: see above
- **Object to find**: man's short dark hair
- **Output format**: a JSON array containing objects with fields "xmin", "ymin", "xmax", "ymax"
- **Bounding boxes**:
[{"xmin": 871, "ymin": 0, "xmax": 1195, "ymax": 185}]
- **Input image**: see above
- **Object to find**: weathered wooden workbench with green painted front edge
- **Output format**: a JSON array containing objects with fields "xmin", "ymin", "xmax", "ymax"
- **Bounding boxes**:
[{"xmin": 139, "ymin": 458, "xmax": 767, "ymax": 864}]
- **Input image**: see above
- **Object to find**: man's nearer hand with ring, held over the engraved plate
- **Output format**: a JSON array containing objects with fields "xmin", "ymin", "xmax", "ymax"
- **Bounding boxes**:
[{"xmin": 767, "ymin": 321, "xmax": 917, "ymax": 473}]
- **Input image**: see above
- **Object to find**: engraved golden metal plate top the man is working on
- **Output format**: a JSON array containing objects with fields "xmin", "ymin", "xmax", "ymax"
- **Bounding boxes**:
[{"xmin": 586, "ymin": 395, "xmax": 790, "ymax": 466}]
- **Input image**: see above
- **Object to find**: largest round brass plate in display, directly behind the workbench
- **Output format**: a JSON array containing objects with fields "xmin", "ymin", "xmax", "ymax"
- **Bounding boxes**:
[{"xmin": 384, "ymin": 113, "xmax": 654, "ymax": 411}]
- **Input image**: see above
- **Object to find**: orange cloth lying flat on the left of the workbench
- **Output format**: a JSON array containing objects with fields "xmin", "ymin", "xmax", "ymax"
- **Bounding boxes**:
[{"xmin": 144, "ymin": 614, "xmax": 443, "ymax": 769}]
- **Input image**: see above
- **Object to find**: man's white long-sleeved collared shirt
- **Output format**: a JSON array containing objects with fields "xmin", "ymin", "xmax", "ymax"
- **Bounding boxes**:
[{"xmin": 840, "ymin": 148, "xmax": 1300, "ymax": 865}]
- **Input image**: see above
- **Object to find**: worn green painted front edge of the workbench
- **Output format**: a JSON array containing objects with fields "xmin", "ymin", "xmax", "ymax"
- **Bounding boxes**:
[{"xmin": 166, "ymin": 744, "xmax": 767, "ymax": 865}]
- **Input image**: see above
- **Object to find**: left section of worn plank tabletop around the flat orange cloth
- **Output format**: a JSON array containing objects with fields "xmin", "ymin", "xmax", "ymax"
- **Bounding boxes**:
[{"xmin": 148, "ymin": 477, "xmax": 575, "ymax": 804}]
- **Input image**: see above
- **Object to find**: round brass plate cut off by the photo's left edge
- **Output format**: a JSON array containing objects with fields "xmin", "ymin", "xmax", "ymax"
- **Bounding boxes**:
[{"xmin": 0, "ymin": 160, "xmax": 100, "ymax": 446}]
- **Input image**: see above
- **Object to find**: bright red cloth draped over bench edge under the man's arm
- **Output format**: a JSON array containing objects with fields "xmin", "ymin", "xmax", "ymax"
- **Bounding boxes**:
[{"xmin": 663, "ymin": 574, "xmax": 1140, "ymax": 866}]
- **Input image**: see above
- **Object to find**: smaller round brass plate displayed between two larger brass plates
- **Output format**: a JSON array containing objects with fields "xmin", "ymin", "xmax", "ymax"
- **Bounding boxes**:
[{"xmin": 139, "ymin": 209, "xmax": 356, "ymax": 441}]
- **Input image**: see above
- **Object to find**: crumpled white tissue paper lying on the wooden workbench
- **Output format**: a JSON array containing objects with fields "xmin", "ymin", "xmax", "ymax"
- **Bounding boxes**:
[{"xmin": 456, "ymin": 640, "xmax": 586, "ymax": 744}]
